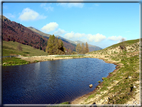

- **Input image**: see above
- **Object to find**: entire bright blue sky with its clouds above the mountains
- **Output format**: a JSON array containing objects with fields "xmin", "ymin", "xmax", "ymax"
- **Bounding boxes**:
[{"xmin": 3, "ymin": 3, "xmax": 140, "ymax": 48}]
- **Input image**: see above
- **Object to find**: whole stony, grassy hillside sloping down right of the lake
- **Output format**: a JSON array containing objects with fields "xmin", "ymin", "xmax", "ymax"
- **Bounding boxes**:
[{"xmin": 74, "ymin": 39, "xmax": 140, "ymax": 104}]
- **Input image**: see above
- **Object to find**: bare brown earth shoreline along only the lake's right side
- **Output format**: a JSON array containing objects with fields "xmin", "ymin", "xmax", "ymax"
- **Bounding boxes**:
[{"xmin": 70, "ymin": 57, "xmax": 121, "ymax": 104}]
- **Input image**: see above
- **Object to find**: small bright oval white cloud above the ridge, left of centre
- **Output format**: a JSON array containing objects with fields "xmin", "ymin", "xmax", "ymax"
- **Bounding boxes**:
[{"xmin": 41, "ymin": 22, "xmax": 58, "ymax": 32}]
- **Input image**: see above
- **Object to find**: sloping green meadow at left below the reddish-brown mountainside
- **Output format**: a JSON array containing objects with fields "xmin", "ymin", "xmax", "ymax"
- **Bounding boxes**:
[{"xmin": 2, "ymin": 41, "xmax": 47, "ymax": 56}]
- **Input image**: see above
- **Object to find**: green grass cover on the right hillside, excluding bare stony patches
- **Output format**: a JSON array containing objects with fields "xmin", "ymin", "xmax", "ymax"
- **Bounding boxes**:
[{"xmin": 85, "ymin": 39, "xmax": 140, "ymax": 104}]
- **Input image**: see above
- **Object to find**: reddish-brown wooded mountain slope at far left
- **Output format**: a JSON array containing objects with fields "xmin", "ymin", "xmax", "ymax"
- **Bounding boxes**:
[{"xmin": 0, "ymin": 16, "xmax": 48, "ymax": 50}]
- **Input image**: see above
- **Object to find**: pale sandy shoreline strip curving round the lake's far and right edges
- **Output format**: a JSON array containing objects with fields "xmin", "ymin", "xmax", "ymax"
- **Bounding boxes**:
[{"xmin": 1, "ymin": 56, "xmax": 121, "ymax": 104}]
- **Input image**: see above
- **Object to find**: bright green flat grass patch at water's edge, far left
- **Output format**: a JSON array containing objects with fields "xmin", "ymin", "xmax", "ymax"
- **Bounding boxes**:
[{"xmin": 2, "ymin": 57, "xmax": 30, "ymax": 66}]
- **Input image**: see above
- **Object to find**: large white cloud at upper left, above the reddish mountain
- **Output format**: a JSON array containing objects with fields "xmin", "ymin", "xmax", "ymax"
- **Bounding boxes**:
[{"xmin": 19, "ymin": 8, "xmax": 46, "ymax": 21}]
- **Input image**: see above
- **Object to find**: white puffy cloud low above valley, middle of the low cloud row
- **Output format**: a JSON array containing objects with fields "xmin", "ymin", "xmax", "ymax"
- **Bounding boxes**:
[{"xmin": 87, "ymin": 33, "xmax": 106, "ymax": 42}]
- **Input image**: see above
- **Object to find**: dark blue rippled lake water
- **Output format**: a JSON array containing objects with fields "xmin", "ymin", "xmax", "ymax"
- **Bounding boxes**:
[{"xmin": 2, "ymin": 58, "xmax": 116, "ymax": 104}]
